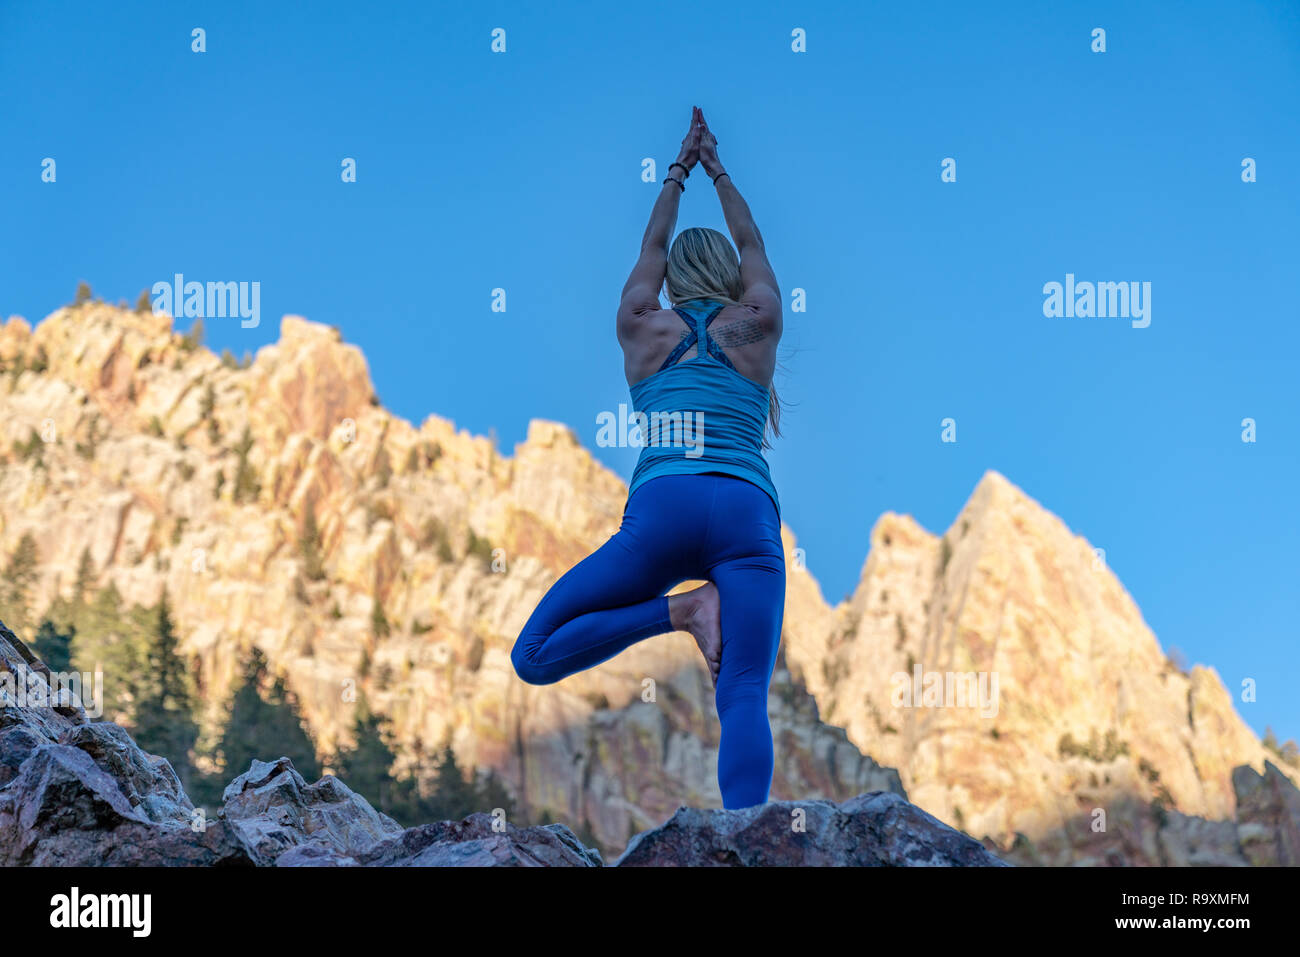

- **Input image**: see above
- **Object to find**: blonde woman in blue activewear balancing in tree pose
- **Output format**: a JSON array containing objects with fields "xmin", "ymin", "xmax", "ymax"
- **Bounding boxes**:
[{"xmin": 511, "ymin": 108, "xmax": 785, "ymax": 807}]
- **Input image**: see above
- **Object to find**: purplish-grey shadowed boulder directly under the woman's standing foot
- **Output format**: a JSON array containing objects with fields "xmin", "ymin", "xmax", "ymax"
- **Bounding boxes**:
[{"xmin": 615, "ymin": 791, "xmax": 1005, "ymax": 867}]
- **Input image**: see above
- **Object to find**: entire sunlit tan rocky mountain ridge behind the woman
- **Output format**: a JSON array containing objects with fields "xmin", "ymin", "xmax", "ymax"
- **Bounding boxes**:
[{"xmin": 0, "ymin": 303, "xmax": 1300, "ymax": 863}]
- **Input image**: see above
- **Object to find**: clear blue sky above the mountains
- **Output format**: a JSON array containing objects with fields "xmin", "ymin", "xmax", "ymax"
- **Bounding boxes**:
[{"xmin": 0, "ymin": 0, "xmax": 1300, "ymax": 737}]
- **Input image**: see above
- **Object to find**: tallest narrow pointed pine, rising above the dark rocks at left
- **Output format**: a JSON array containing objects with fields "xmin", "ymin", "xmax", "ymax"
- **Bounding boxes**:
[{"xmin": 134, "ymin": 590, "xmax": 199, "ymax": 788}]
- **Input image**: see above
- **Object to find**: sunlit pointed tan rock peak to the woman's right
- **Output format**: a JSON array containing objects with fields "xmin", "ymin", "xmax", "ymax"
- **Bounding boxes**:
[{"xmin": 785, "ymin": 472, "xmax": 1296, "ymax": 863}]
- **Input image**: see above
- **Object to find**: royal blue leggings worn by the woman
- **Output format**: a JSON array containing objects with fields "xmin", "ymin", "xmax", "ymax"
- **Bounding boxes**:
[{"xmin": 510, "ymin": 473, "xmax": 785, "ymax": 807}]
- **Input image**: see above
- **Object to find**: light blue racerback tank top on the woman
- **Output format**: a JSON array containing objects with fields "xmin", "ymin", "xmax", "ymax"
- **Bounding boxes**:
[{"xmin": 628, "ymin": 299, "xmax": 781, "ymax": 516}]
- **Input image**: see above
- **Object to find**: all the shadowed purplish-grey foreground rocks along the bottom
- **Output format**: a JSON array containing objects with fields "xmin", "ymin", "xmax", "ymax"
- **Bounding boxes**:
[{"xmin": 0, "ymin": 624, "xmax": 982, "ymax": 867}]
